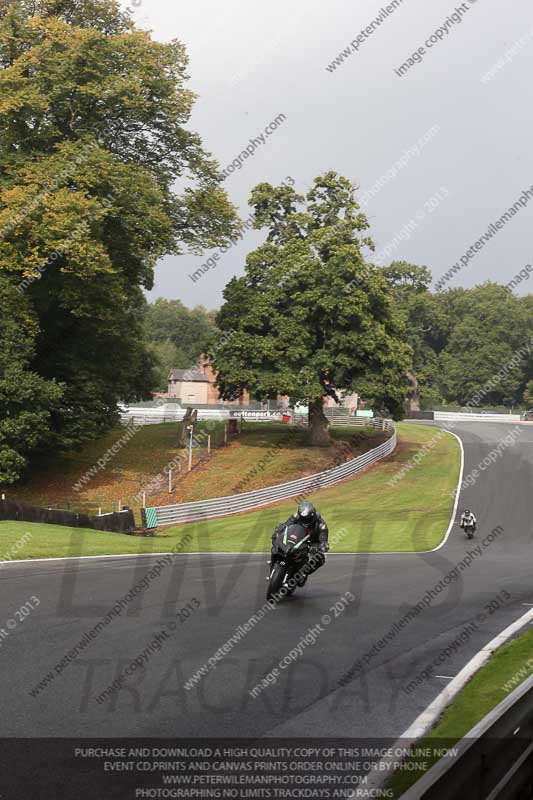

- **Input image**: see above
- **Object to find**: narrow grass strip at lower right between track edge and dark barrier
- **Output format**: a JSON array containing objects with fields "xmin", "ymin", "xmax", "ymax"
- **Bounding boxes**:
[{"xmin": 387, "ymin": 631, "xmax": 533, "ymax": 798}]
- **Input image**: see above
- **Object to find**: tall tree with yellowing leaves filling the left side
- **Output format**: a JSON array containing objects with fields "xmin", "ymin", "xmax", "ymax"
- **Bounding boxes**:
[{"xmin": 0, "ymin": 0, "xmax": 237, "ymax": 481}]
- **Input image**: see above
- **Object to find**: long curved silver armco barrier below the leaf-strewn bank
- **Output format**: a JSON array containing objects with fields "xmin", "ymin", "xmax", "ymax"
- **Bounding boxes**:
[{"xmin": 141, "ymin": 420, "xmax": 397, "ymax": 528}]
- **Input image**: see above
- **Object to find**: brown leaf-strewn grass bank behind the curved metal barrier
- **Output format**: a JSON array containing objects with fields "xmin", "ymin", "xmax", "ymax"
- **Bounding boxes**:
[{"xmin": 7, "ymin": 421, "xmax": 383, "ymax": 519}]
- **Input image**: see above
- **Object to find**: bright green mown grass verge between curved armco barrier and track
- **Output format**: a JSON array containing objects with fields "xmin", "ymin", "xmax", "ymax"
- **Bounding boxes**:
[{"xmin": 0, "ymin": 424, "xmax": 460, "ymax": 558}]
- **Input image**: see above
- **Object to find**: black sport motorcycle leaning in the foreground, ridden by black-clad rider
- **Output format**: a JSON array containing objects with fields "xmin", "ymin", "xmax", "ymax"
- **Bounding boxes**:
[{"xmin": 267, "ymin": 525, "xmax": 314, "ymax": 600}]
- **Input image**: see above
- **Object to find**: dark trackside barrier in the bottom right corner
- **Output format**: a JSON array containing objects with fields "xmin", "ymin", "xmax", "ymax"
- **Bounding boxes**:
[{"xmin": 402, "ymin": 677, "xmax": 533, "ymax": 800}]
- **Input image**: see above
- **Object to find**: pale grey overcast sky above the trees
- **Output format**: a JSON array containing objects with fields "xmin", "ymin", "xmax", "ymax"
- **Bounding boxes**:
[{"xmin": 123, "ymin": 0, "xmax": 533, "ymax": 308}]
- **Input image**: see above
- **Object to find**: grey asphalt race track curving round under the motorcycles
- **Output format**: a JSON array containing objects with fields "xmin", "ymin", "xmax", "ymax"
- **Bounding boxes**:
[{"xmin": 0, "ymin": 423, "xmax": 533, "ymax": 737}]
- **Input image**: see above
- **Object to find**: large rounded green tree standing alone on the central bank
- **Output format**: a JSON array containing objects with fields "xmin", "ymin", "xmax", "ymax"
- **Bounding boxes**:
[{"xmin": 215, "ymin": 172, "xmax": 410, "ymax": 443}]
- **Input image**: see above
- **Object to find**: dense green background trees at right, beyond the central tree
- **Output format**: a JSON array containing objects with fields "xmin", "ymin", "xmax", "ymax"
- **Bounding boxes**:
[{"xmin": 384, "ymin": 274, "xmax": 533, "ymax": 408}]
